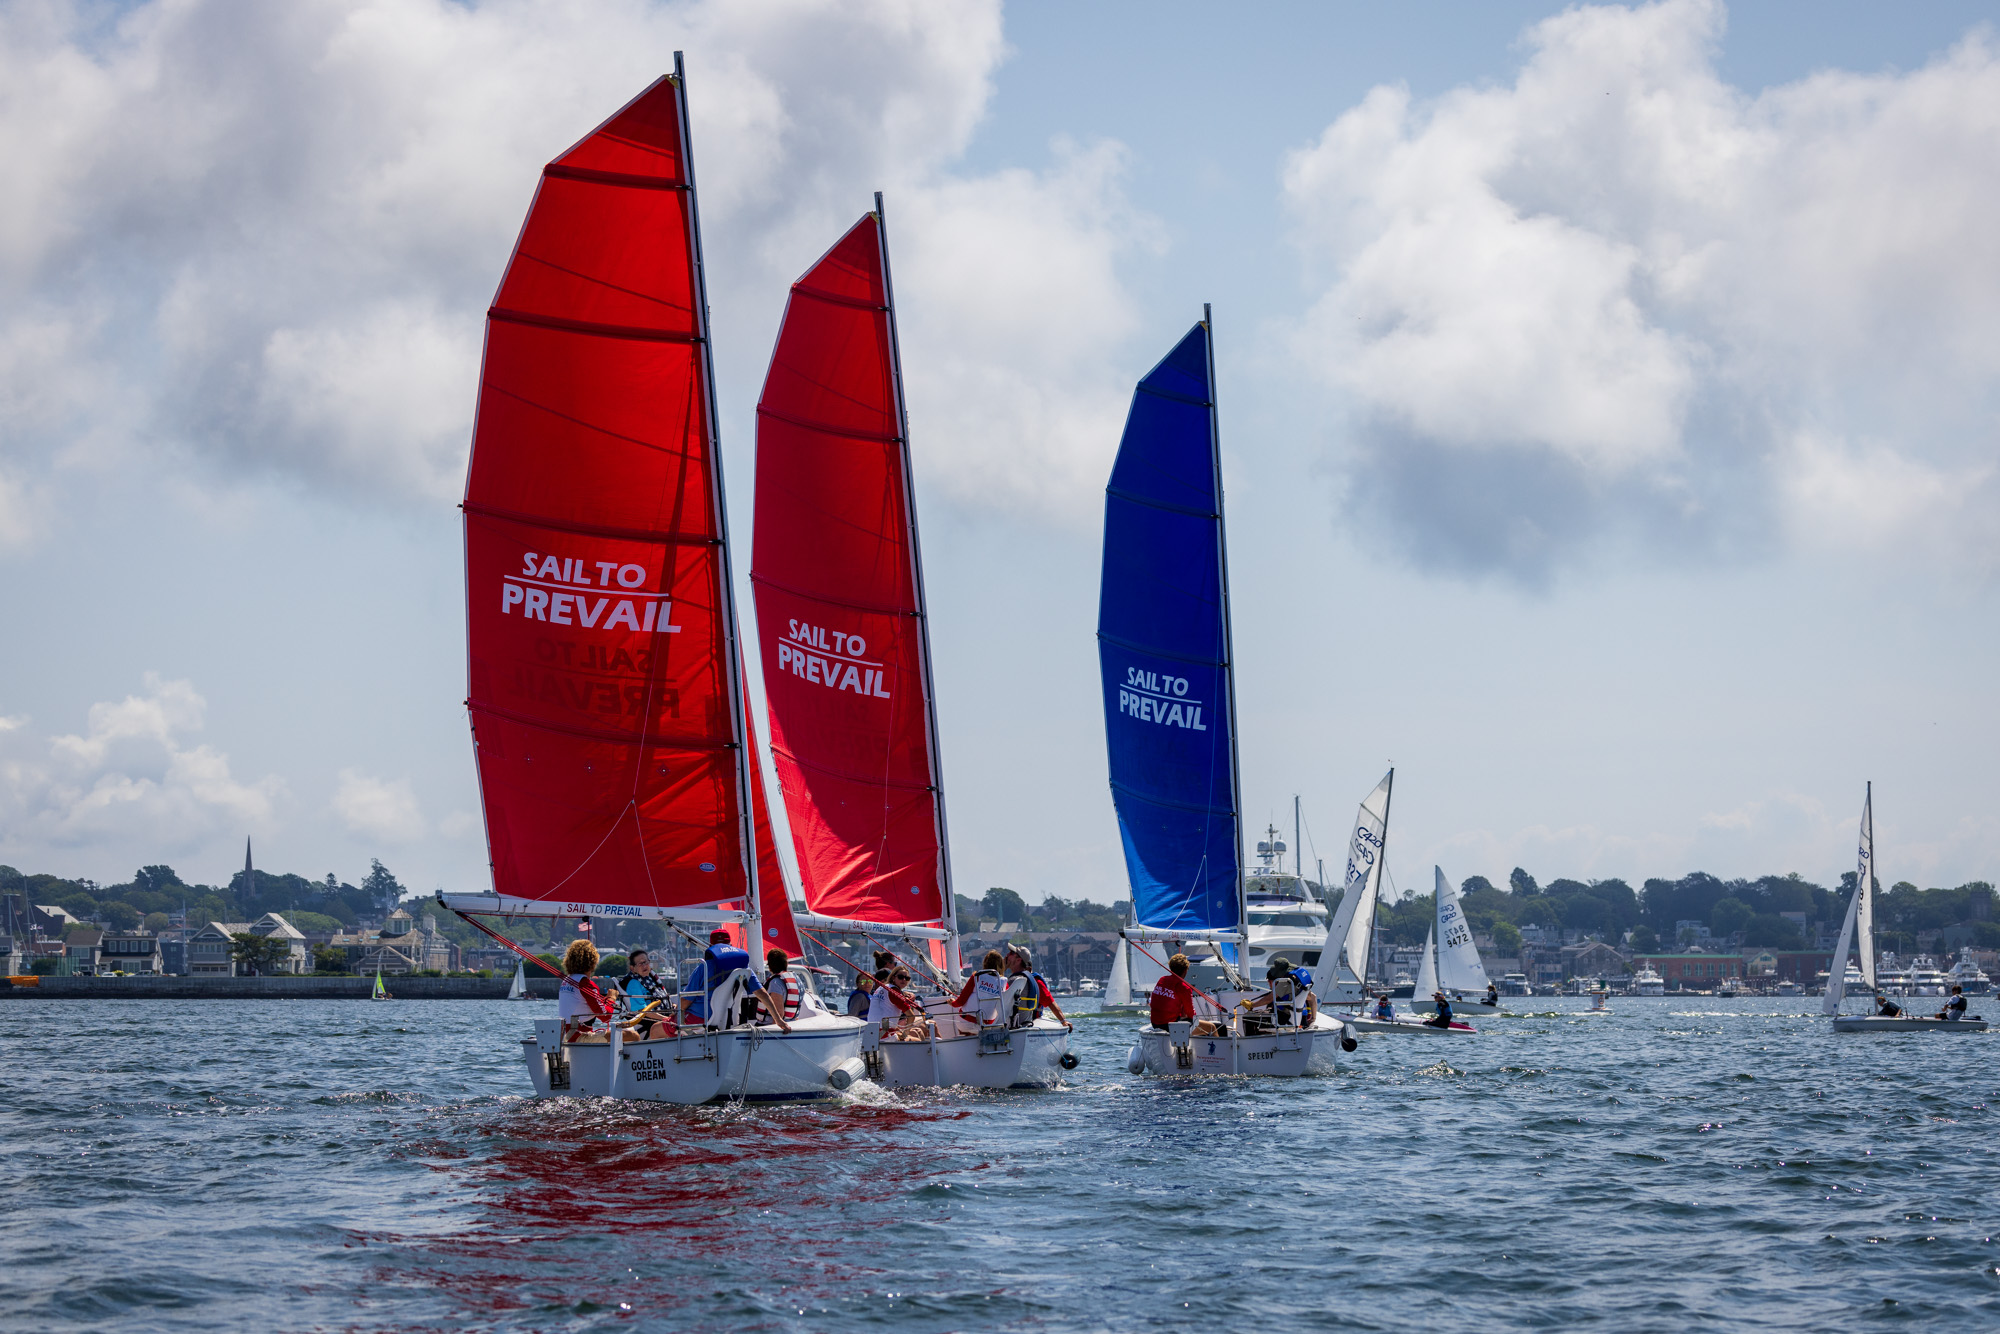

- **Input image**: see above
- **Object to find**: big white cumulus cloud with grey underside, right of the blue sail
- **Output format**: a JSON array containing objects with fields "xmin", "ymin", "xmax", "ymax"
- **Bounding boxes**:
[{"xmin": 1284, "ymin": 0, "xmax": 2000, "ymax": 582}]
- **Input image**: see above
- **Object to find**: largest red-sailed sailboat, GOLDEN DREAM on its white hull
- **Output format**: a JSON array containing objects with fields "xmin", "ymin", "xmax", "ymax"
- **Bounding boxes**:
[{"xmin": 452, "ymin": 54, "xmax": 864, "ymax": 1104}]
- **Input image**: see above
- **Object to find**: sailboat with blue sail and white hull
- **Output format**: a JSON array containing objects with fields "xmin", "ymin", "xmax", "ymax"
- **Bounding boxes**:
[{"xmin": 1098, "ymin": 306, "xmax": 1352, "ymax": 1076}]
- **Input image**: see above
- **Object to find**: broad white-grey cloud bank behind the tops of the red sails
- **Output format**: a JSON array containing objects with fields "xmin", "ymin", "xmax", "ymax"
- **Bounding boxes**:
[{"xmin": 0, "ymin": 0, "xmax": 1150, "ymax": 528}]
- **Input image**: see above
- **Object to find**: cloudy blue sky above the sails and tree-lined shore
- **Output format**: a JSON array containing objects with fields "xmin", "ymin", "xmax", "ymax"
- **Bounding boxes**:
[{"xmin": 0, "ymin": 0, "xmax": 2000, "ymax": 902}]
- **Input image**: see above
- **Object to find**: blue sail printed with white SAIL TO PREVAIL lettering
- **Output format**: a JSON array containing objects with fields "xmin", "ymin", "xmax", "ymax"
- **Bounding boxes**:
[{"xmin": 1098, "ymin": 324, "xmax": 1240, "ymax": 930}]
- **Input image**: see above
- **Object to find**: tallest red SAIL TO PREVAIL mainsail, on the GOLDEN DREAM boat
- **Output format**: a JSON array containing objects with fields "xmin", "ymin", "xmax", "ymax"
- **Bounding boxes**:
[{"xmin": 464, "ymin": 78, "xmax": 750, "ymax": 908}]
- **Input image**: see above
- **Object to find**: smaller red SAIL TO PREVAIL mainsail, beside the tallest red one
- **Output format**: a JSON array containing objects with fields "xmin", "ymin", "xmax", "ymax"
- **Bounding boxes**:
[{"xmin": 750, "ymin": 214, "xmax": 944, "ymax": 922}]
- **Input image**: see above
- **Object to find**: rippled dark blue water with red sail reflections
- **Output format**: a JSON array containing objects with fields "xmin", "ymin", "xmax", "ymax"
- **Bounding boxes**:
[{"xmin": 0, "ymin": 998, "xmax": 2000, "ymax": 1332}]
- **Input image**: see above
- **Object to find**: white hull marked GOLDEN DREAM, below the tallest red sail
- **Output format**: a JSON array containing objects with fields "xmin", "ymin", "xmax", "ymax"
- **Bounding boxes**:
[{"xmin": 522, "ymin": 1014, "xmax": 866, "ymax": 1106}]
